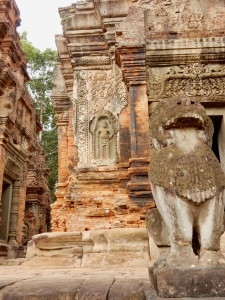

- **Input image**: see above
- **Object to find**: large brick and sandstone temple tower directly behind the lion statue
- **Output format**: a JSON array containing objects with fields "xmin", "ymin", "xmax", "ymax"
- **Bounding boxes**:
[{"xmin": 52, "ymin": 0, "xmax": 225, "ymax": 231}]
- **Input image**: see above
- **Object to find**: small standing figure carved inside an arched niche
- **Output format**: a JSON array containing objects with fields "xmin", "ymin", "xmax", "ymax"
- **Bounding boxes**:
[{"xmin": 90, "ymin": 110, "xmax": 118, "ymax": 165}]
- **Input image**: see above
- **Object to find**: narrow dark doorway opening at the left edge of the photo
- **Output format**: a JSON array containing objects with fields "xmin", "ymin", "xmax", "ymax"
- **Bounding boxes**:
[{"xmin": 0, "ymin": 177, "xmax": 13, "ymax": 243}]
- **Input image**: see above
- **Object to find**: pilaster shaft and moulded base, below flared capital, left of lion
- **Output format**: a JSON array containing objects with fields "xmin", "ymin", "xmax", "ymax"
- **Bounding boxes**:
[{"xmin": 128, "ymin": 81, "xmax": 152, "ymax": 206}]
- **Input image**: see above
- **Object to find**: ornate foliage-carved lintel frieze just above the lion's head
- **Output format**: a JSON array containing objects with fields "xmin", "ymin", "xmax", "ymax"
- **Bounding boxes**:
[{"xmin": 147, "ymin": 63, "xmax": 225, "ymax": 100}]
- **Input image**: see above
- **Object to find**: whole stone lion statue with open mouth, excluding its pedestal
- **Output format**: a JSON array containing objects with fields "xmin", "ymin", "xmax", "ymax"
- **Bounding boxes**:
[{"xmin": 149, "ymin": 96, "xmax": 225, "ymax": 266}]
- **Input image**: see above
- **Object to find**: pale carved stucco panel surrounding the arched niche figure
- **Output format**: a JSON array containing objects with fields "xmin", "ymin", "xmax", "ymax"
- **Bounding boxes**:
[{"xmin": 72, "ymin": 65, "xmax": 127, "ymax": 167}]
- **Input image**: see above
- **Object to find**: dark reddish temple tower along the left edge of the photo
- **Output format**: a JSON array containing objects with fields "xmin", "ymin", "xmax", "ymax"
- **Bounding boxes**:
[{"xmin": 0, "ymin": 0, "xmax": 50, "ymax": 261}]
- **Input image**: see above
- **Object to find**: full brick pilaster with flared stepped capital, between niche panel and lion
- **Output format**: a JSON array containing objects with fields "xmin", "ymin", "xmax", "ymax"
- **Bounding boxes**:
[{"xmin": 116, "ymin": 47, "xmax": 154, "ymax": 207}]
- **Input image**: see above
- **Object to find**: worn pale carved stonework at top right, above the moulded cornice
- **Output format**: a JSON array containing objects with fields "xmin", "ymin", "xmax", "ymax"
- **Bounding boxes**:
[{"xmin": 146, "ymin": 0, "xmax": 225, "ymax": 38}]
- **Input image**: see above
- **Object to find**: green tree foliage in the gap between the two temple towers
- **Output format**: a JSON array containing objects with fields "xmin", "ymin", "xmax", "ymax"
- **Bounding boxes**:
[{"xmin": 20, "ymin": 32, "xmax": 58, "ymax": 201}]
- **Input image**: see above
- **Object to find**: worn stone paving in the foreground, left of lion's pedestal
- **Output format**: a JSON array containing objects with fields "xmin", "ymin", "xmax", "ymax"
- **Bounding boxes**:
[{"xmin": 0, "ymin": 260, "xmax": 225, "ymax": 300}]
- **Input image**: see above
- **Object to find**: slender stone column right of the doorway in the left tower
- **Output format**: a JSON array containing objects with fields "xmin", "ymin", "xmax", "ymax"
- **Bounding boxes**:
[{"xmin": 7, "ymin": 180, "xmax": 21, "ymax": 259}]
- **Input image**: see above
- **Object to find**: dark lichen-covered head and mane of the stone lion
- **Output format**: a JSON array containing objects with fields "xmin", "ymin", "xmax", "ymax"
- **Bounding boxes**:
[{"xmin": 149, "ymin": 98, "xmax": 225, "ymax": 204}]
